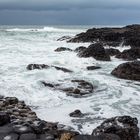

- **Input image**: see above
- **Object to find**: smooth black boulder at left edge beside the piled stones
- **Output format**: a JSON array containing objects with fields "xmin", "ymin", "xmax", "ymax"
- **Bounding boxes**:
[{"xmin": 0, "ymin": 112, "xmax": 10, "ymax": 126}]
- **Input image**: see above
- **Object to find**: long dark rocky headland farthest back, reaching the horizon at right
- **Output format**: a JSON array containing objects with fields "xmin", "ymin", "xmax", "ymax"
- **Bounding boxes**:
[{"xmin": 68, "ymin": 25, "xmax": 140, "ymax": 47}]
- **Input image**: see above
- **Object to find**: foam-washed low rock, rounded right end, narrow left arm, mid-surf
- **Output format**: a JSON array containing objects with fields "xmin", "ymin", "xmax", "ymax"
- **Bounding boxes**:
[{"xmin": 42, "ymin": 80, "xmax": 94, "ymax": 97}]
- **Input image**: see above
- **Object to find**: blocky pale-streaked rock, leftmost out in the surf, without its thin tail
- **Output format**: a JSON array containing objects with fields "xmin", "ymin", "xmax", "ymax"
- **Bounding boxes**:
[{"xmin": 27, "ymin": 64, "xmax": 49, "ymax": 70}]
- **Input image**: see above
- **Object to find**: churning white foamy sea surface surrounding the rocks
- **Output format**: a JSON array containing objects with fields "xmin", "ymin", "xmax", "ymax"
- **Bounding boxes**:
[{"xmin": 0, "ymin": 26, "xmax": 140, "ymax": 134}]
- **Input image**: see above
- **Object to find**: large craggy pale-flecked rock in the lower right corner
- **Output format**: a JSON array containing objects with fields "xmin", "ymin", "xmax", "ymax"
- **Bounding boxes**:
[{"xmin": 92, "ymin": 116, "xmax": 139, "ymax": 140}]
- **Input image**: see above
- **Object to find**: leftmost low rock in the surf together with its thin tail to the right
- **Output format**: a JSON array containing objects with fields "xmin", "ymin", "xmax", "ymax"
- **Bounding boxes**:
[{"xmin": 26, "ymin": 64, "xmax": 72, "ymax": 73}]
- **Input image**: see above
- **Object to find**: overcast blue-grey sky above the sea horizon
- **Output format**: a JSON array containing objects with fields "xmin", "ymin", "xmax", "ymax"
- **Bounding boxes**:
[{"xmin": 0, "ymin": 0, "xmax": 140, "ymax": 25}]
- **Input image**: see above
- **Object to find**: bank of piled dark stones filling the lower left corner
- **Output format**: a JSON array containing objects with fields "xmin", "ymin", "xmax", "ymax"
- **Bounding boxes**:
[{"xmin": 0, "ymin": 97, "xmax": 78, "ymax": 140}]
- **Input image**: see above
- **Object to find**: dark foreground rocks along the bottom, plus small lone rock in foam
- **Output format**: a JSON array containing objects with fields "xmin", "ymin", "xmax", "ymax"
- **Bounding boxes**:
[{"xmin": 0, "ymin": 96, "xmax": 139, "ymax": 140}]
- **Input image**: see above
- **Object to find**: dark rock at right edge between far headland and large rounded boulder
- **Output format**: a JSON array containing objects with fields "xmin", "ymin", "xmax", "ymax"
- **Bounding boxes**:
[{"xmin": 116, "ymin": 48, "xmax": 140, "ymax": 60}]
